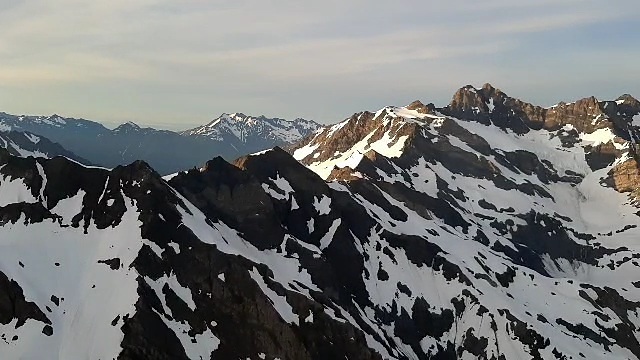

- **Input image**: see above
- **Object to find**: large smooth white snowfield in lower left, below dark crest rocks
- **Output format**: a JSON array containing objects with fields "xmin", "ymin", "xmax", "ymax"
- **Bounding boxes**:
[{"xmin": 0, "ymin": 190, "xmax": 142, "ymax": 359}]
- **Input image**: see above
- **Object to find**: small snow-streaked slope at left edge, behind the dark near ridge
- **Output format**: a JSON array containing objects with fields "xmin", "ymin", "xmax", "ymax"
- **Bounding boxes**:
[{"xmin": 0, "ymin": 131, "xmax": 89, "ymax": 164}]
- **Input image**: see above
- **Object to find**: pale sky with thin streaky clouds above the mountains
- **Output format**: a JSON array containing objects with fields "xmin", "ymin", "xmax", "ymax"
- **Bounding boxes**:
[{"xmin": 0, "ymin": 0, "xmax": 640, "ymax": 129}]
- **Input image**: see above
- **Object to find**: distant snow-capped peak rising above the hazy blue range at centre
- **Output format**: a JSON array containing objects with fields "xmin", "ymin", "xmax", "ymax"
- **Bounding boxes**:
[{"xmin": 182, "ymin": 113, "xmax": 322, "ymax": 149}]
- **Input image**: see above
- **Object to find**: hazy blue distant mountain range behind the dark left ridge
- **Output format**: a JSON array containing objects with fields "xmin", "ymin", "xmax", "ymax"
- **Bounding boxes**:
[{"xmin": 0, "ymin": 113, "xmax": 319, "ymax": 174}]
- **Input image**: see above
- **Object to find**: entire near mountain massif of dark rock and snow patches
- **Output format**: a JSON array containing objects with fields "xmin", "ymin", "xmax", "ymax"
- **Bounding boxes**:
[{"xmin": 0, "ymin": 84, "xmax": 640, "ymax": 360}]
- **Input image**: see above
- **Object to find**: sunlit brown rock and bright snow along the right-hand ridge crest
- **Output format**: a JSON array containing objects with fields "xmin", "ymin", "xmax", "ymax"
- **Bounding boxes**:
[{"xmin": 289, "ymin": 84, "xmax": 640, "ymax": 183}]
